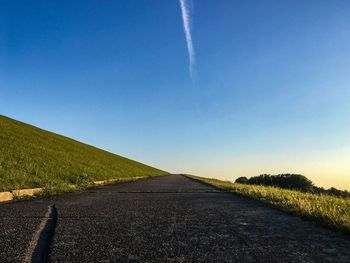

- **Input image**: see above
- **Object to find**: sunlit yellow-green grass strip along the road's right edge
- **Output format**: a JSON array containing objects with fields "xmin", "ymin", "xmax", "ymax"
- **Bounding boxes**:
[{"xmin": 188, "ymin": 175, "xmax": 350, "ymax": 234}]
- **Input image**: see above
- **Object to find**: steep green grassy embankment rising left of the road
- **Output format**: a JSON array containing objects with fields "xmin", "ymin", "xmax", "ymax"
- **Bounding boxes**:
[{"xmin": 0, "ymin": 115, "xmax": 166, "ymax": 191}]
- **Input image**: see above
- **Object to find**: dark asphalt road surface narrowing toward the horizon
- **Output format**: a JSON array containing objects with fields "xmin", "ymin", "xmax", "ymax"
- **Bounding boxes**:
[{"xmin": 0, "ymin": 175, "xmax": 350, "ymax": 262}]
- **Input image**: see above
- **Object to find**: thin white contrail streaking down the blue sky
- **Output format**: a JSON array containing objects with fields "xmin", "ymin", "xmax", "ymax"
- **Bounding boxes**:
[{"xmin": 179, "ymin": 0, "xmax": 196, "ymax": 81}]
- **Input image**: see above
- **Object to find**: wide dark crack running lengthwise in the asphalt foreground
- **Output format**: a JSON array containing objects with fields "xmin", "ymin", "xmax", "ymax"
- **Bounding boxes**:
[{"xmin": 23, "ymin": 204, "xmax": 57, "ymax": 263}]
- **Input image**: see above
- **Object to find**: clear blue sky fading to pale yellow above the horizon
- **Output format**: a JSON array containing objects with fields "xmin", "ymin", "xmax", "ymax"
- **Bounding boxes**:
[{"xmin": 0, "ymin": 0, "xmax": 350, "ymax": 189}]
